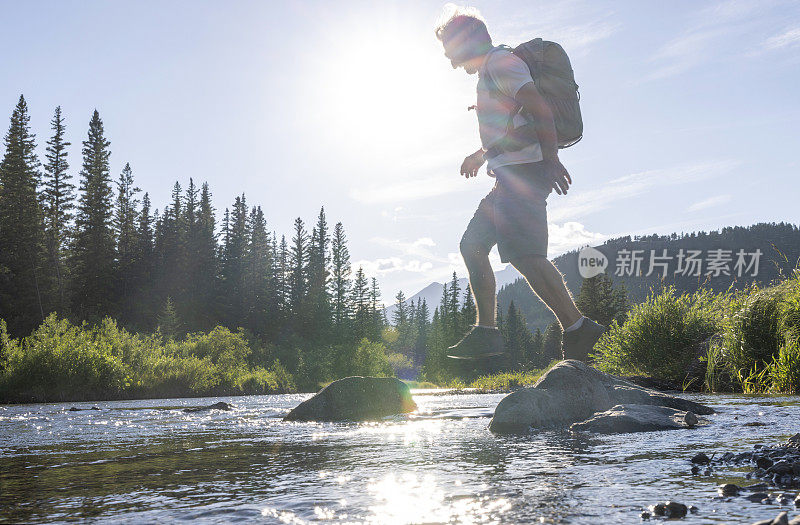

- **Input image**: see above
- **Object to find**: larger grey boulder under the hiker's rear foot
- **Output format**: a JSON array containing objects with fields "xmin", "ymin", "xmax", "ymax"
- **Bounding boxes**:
[{"xmin": 489, "ymin": 359, "xmax": 714, "ymax": 433}]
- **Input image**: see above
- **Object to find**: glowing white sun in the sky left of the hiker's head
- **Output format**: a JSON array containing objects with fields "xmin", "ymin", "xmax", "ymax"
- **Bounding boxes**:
[{"xmin": 312, "ymin": 18, "xmax": 462, "ymax": 156}]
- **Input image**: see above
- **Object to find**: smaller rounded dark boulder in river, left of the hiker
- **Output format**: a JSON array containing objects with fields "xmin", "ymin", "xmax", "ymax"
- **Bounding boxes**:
[{"xmin": 283, "ymin": 376, "xmax": 417, "ymax": 421}]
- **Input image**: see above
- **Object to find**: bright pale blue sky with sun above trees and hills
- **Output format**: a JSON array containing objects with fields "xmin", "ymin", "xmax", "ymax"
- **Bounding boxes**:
[{"xmin": 0, "ymin": 0, "xmax": 800, "ymax": 302}]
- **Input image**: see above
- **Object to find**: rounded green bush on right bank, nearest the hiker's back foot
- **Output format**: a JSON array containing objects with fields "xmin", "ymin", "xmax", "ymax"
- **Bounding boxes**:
[{"xmin": 594, "ymin": 287, "xmax": 728, "ymax": 383}]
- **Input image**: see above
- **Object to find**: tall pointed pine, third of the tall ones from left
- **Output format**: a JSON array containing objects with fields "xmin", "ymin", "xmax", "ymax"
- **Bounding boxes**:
[{"xmin": 72, "ymin": 110, "xmax": 116, "ymax": 321}]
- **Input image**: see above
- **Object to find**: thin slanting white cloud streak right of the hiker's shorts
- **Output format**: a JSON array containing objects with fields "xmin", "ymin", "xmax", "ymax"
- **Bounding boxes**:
[{"xmin": 547, "ymin": 160, "xmax": 738, "ymax": 222}]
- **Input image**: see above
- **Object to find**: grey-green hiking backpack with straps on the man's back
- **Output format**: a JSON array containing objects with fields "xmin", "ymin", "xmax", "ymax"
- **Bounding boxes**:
[{"xmin": 486, "ymin": 38, "xmax": 583, "ymax": 158}]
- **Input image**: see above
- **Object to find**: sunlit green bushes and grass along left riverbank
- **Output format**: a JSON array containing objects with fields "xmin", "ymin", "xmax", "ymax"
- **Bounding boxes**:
[{"xmin": 0, "ymin": 315, "xmax": 294, "ymax": 402}]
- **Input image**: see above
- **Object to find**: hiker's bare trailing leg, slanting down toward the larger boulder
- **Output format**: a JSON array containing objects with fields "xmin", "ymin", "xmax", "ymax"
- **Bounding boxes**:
[{"xmin": 511, "ymin": 255, "xmax": 582, "ymax": 329}]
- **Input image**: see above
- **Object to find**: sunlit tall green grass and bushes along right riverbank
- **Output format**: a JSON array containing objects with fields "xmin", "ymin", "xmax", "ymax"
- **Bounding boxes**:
[{"xmin": 594, "ymin": 270, "xmax": 800, "ymax": 393}]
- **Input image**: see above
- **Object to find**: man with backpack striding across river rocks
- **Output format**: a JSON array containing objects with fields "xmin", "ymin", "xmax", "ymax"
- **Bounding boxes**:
[{"xmin": 436, "ymin": 8, "xmax": 605, "ymax": 361}]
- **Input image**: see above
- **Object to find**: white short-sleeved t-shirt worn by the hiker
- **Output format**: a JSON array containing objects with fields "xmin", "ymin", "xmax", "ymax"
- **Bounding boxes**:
[{"xmin": 477, "ymin": 47, "xmax": 543, "ymax": 170}]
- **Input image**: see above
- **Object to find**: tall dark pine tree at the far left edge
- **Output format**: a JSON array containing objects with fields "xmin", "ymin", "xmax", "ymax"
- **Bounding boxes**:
[{"xmin": 0, "ymin": 96, "xmax": 46, "ymax": 336}]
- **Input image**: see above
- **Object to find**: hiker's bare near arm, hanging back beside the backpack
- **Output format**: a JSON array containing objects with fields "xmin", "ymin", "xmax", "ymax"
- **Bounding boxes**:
[{"xmin": 515, "ymin": 82, "xmax": 572, "ymax": 194}]
